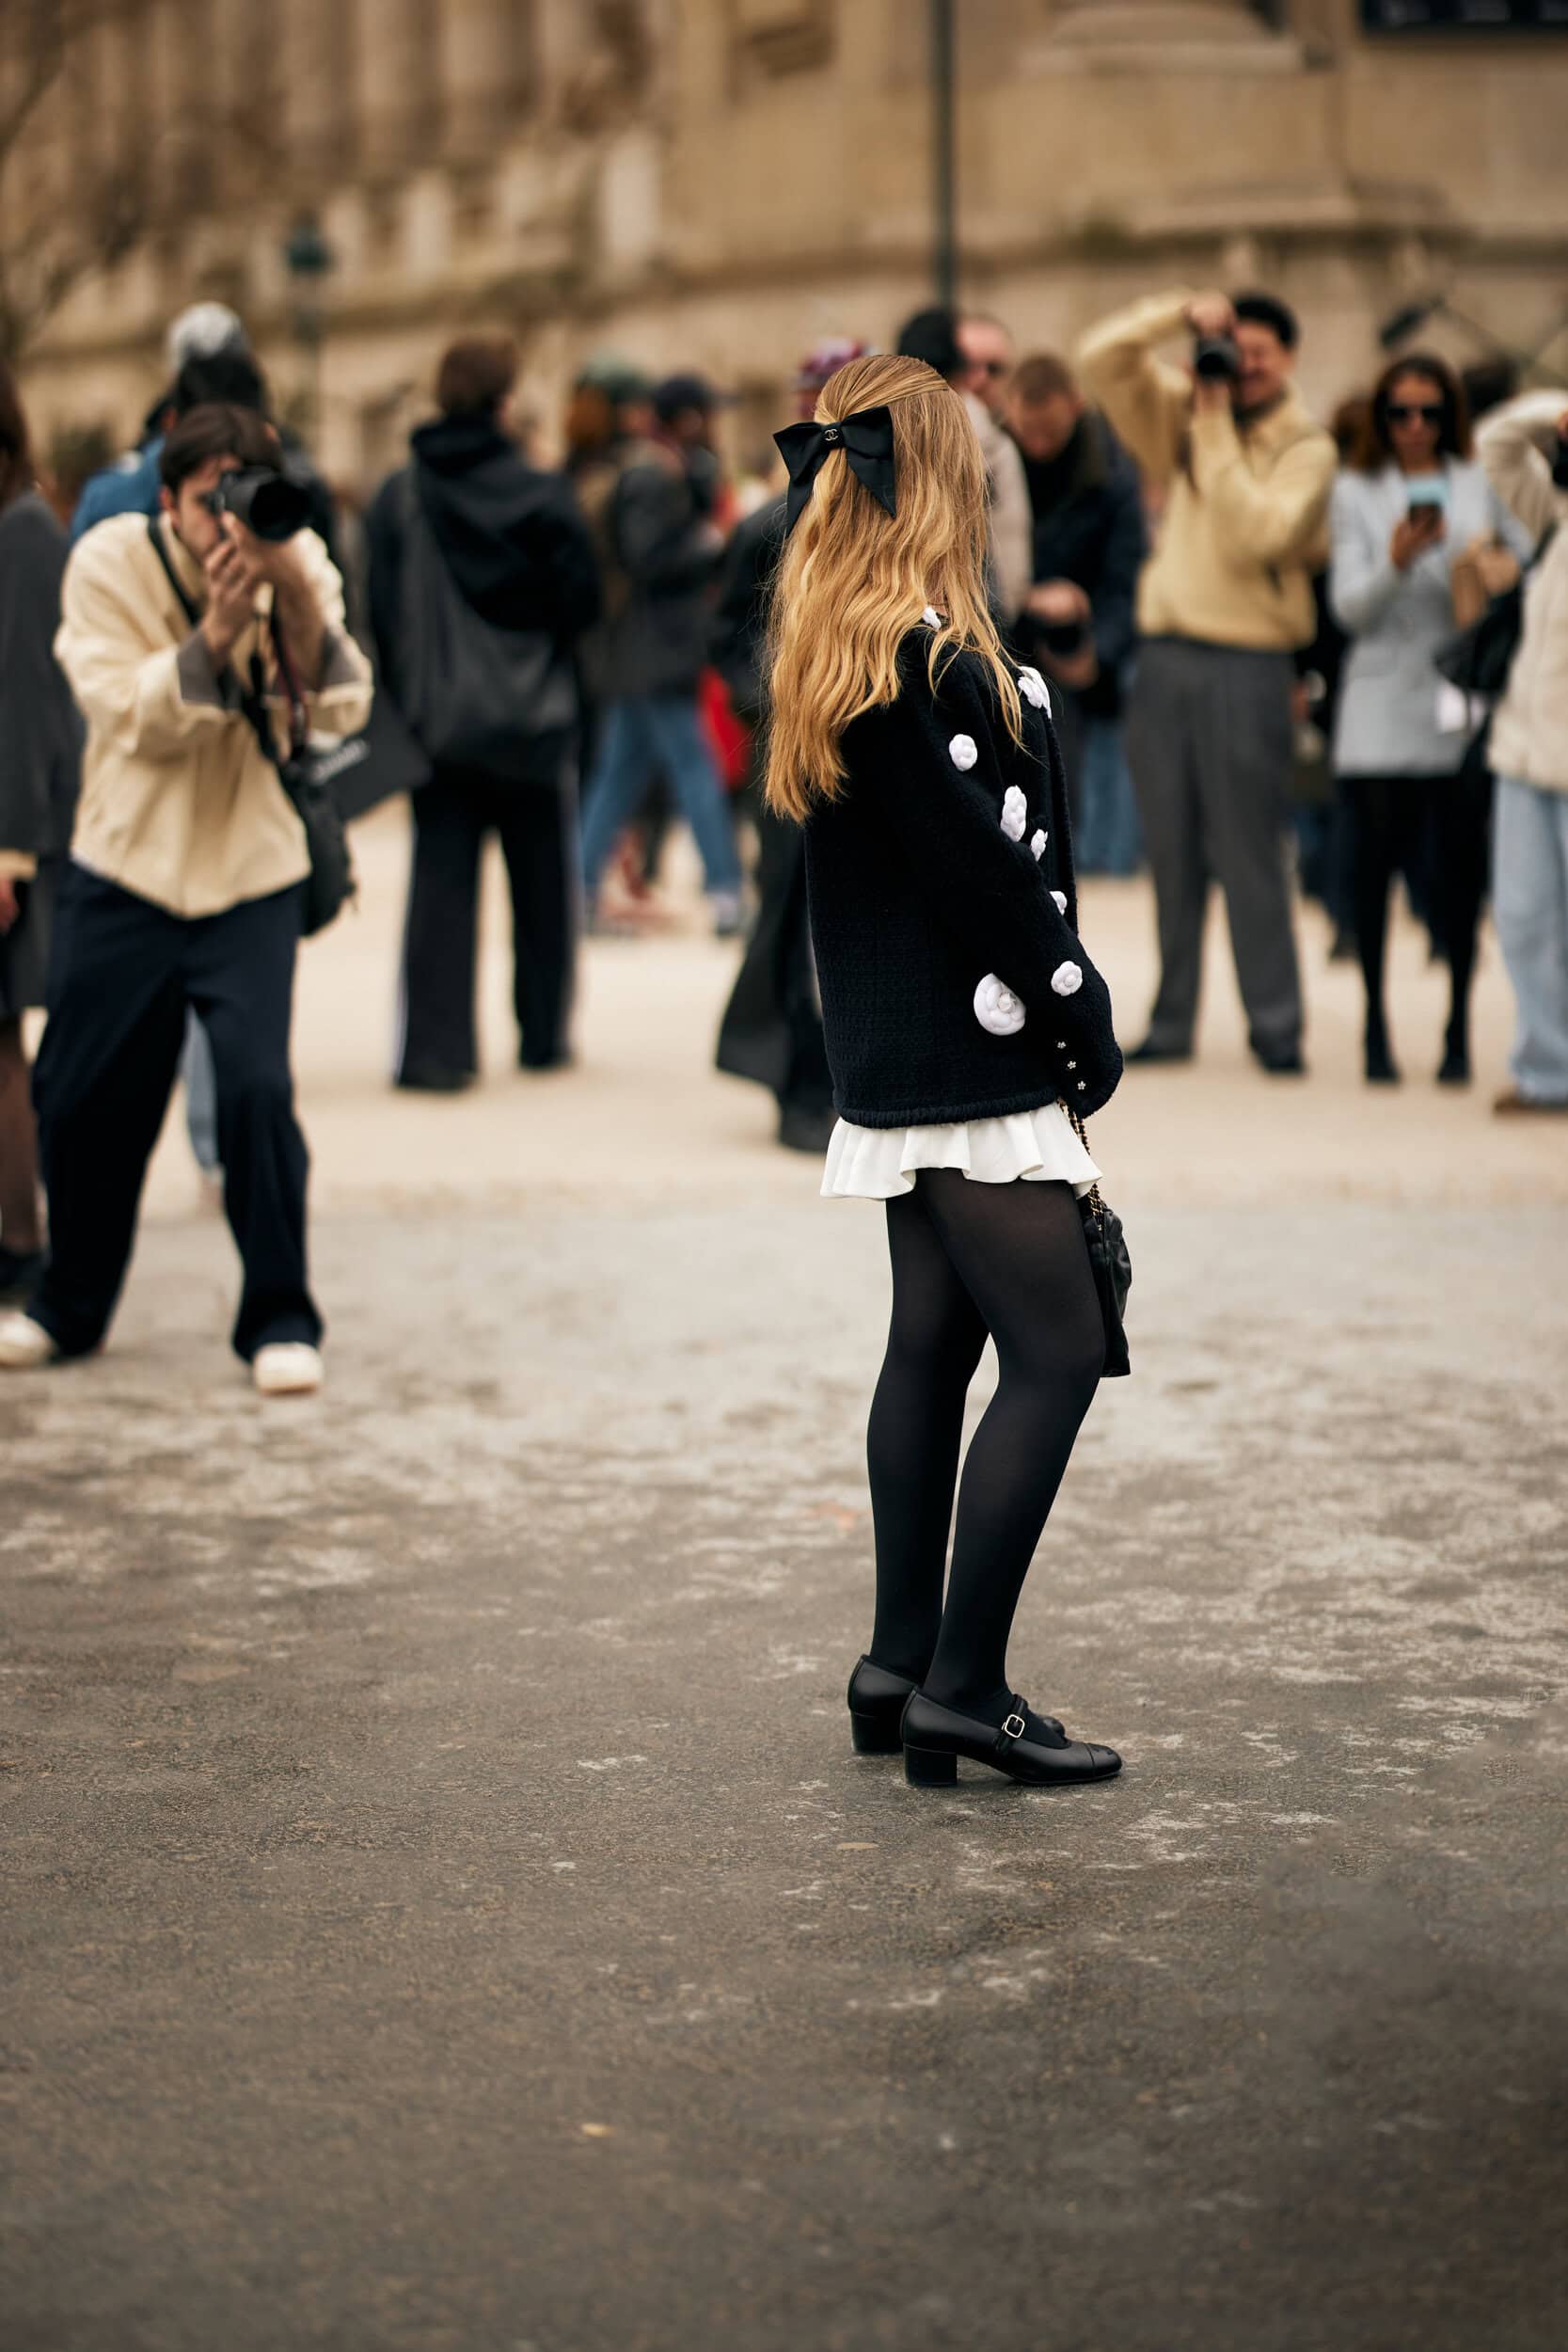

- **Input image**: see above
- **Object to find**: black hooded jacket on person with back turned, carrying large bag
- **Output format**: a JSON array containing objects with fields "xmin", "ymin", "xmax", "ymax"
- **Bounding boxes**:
[{"xmin": 364, "ymin": 417, "xmax": 599, "ymax": 701}]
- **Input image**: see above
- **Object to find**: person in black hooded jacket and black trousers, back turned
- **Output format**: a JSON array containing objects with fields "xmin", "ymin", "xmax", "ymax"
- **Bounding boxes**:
[{"xmin": 364, "ymin": 337, "xmax": 599, "ymax": 1094}]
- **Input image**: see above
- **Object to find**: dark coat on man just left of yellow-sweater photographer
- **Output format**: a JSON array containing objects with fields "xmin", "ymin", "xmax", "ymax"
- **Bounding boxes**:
[{"xmin": 1018, "ymin": 412, "xmax": 1148, "ymax": 718}]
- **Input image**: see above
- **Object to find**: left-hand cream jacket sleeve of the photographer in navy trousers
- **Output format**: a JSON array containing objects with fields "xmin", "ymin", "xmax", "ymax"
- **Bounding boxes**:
[{"xmin": 54, "ymin": 532, "xmax": 245, "ymax": 760}]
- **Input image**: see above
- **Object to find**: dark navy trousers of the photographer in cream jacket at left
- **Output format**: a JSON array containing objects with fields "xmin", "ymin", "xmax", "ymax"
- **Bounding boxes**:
[{"xmin": 28, "ymin": 866, "xmax": 322, "ymax": 1362}]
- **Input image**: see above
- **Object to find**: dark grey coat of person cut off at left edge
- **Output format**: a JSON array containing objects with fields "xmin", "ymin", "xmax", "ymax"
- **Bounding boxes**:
[{"xmin": 0, "ymin": 492, "xmax": 82, "ymax": 859}]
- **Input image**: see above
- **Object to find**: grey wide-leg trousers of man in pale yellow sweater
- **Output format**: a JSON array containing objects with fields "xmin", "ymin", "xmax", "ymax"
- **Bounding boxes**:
[{"xmin": 1126, "ymin": 638, "xmax": 1303, "ymax": 1057}]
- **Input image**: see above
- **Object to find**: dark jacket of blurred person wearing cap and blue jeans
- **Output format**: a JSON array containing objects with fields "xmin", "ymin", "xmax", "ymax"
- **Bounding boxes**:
[{"xmin": 578, "ymin": 442, "xmax": 720, "ymax": 701}]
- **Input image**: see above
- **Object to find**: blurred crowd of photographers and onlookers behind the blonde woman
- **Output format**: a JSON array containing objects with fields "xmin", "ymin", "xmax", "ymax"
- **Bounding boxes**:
[{"xmin": 0, "ymin": 290, "xmax": 1568, "ymax": 1386}]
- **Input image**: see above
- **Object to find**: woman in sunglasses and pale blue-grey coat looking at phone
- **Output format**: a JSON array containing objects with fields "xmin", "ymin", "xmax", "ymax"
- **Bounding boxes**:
[{"xmin": 1328, "ymin": 353, "xmax": 1528, "ymax": 1087}]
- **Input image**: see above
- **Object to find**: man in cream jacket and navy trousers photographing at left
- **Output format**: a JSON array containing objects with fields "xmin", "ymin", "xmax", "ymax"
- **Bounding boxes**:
[{"xmin": 0, "ymin": 405, "xmax": 372, "ymax": 1395}]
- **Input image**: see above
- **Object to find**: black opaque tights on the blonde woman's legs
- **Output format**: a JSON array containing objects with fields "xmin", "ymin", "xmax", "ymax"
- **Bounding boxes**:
[{"xmin": 867, "ymin": 1169, "xmax": 1105, "ymax": 1712}]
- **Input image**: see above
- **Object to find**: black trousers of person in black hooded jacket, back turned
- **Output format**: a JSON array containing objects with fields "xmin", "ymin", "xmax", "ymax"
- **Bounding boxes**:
[{"xmin": 397, "ymin": 770, "xmax": 578, "ymax": 1077}]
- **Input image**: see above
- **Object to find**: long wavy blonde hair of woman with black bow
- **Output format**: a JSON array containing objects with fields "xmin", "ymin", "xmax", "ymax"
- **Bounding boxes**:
[{"xmin": 767, "ymin": 356, "xmax": 1022, "ymax": 823}]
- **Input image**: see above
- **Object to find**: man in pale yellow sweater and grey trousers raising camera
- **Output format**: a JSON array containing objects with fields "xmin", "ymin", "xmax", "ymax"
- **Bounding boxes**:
[{"xmin": 1079, "ymin": 294, "xmax": 1336, "ymax": 1075}]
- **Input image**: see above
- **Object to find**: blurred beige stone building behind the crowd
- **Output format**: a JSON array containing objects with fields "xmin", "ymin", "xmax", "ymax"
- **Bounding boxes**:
[{"xmin": 5, "ymin": 0, "xmax": 1568, "ymax": 480}]
